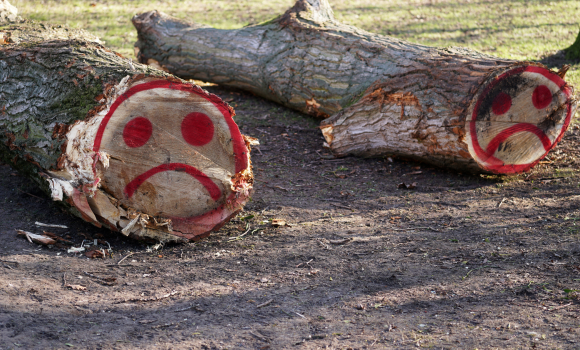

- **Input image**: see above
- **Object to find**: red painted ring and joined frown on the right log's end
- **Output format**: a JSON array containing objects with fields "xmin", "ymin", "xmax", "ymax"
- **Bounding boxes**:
[{"xmin": 469, "ymin": 66, "xmax": 572, "ymax": 174}]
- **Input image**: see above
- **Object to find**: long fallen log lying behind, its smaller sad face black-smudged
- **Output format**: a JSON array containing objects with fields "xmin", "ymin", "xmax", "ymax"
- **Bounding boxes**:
[{"xmin": 133, "ymin": 0, "xmax": 576, "ymax": 173}]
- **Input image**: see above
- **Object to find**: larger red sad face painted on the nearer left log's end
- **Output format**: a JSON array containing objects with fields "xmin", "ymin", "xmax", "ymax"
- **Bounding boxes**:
[{"xmin": 93, "ymin": 81, "xmax": 248, "ymax": 218}]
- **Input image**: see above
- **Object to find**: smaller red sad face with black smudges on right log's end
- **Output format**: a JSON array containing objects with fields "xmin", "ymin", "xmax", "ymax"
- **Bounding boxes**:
[{"xmin": 466, "ymin": 66, "xmax": 573, "ymax": 173}]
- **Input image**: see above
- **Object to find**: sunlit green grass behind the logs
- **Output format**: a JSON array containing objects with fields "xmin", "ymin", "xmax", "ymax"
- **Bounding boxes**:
[{"xmin": 7, "ymin": 0, "xmax": 580, "ymax": 86}]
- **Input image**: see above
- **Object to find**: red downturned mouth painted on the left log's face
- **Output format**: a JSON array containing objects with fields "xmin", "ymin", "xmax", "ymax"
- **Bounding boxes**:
[{"xmin": 124, "ymin": 163, "xmax": 222, "ymax": 201}]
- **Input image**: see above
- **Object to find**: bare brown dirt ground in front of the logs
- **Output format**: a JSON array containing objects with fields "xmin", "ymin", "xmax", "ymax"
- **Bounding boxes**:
[{"xmin": 0, "ymin": 83, "xmax": 580, "ymax": 350}]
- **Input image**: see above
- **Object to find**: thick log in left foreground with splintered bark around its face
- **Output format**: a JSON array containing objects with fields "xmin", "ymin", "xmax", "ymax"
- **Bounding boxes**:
[{"xmin": 0, "ymin": 15, "xmax": 253, "ymax": 242}]
